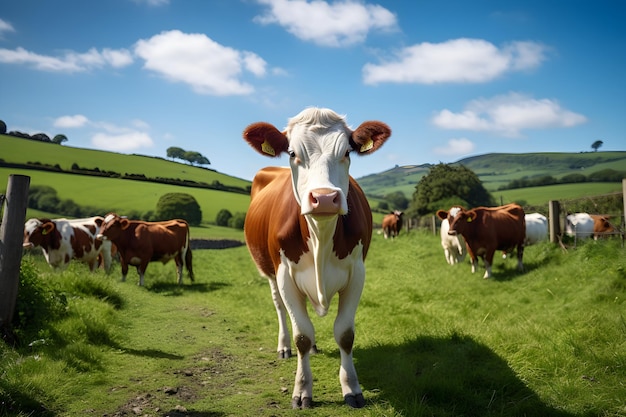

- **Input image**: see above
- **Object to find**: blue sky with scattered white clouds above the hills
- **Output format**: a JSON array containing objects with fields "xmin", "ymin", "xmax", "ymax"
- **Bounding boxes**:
[{"xmin": 0, "ymin": 0, "xmax": 626, "ymax": 179}]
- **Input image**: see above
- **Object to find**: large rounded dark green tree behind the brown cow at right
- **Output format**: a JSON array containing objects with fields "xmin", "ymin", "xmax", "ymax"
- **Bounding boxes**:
[{"xmin": 408, "ymin": 164, "xmax": 495, "ymax": 215}]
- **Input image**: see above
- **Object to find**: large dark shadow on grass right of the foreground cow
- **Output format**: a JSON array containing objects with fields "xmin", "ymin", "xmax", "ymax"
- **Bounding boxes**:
[{"xmin": 355, "ymin": 334, "xmax": 573, "ymax": 417}]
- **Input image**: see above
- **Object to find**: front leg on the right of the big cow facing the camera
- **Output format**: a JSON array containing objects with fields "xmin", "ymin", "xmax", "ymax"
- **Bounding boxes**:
[{"xmin": 334, "ymin": 265, "xmax": 365, "ymax": 408}]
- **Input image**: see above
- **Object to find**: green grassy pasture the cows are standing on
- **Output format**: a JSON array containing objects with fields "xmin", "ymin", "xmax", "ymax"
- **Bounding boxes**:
[{"xmin": 0, "ymin": 231, "xmax": 626, "ymax": 417}]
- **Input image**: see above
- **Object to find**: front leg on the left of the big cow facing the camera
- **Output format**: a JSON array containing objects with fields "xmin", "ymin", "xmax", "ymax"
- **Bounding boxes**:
[{"xmin": 276, "ymin": 264, "xmax": 315, "ymax": 408}]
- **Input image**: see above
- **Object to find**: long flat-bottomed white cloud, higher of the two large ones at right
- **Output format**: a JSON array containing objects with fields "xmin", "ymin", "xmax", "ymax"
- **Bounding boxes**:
[{"xmin": 363, "ymin": 38, "xmax": 547, "ymax": 84}]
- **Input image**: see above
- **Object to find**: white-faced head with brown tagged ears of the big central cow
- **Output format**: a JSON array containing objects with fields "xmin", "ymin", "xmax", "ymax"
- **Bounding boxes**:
[{"xmin": 243, "ymin": 108, "xmax": 391, "ymax": 216}]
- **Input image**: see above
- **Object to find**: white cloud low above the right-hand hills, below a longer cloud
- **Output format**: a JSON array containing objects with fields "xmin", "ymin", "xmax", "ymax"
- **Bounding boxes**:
[{"xmin": 432, "ymin": 93, "xmax": 587, "ymax": 137}]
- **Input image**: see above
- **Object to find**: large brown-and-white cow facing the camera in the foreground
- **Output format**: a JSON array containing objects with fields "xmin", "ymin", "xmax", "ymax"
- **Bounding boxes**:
[{"xmin": 243, "ymin": 108, "xmax": 391, "ymax": 408}]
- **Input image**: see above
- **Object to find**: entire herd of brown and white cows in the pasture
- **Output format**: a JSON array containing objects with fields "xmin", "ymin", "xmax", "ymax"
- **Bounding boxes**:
[{"xmin": 19, "ymin": 108, "xmax": 613, "ymax": 408}]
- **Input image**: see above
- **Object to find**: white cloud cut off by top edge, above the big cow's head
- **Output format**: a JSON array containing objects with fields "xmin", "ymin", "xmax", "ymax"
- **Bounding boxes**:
[{"xmin": 254, "ymin": 0, "xmax": 397, "ymax": 47}]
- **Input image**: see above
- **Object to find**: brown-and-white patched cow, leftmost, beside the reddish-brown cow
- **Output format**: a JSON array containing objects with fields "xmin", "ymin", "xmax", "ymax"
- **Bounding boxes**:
[{"xmin": 22, "ymin": 216, "xmax": 111, "ymax": 272}]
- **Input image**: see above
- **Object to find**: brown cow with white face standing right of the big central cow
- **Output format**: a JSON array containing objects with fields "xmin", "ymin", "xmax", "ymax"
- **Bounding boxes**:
[{"xmin": 437, "ymin": 204, "xmax": 526, "ymax": 278}]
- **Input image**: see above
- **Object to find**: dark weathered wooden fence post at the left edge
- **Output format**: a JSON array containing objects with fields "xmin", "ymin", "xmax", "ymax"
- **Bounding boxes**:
[{"xmin": 0, "ymin": 175, "xmax": 30, "ymax": 341}]
